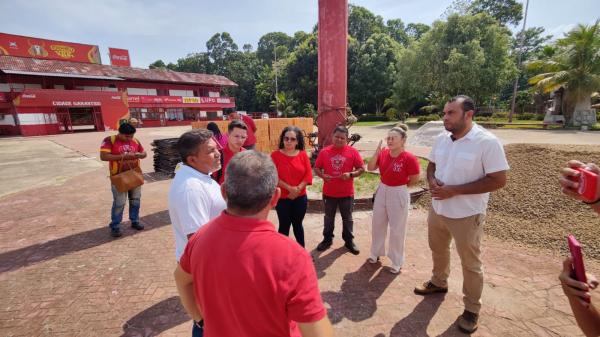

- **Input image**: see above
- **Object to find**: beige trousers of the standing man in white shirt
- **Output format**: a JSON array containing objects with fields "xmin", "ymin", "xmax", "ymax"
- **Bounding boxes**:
[{"xmin": 427, "ymin": 208, "xmax": 485, "ymax": 313}]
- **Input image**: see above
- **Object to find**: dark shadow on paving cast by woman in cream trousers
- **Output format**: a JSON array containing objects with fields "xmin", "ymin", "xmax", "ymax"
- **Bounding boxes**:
[{"xmin": 321, "ymin": 262, "xmax": 398, "ymax": 324}]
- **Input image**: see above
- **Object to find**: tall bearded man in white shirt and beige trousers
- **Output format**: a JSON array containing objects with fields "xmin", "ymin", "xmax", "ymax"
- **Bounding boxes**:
[{"xmin": 415, "ymin": 95, "xmax": 509, "ymax": 333}]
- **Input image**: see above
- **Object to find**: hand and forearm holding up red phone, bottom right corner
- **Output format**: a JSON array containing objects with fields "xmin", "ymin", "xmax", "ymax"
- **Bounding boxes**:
[{"xmin": 558, "ymin": 257, "xmax": 600, "ymax": 336}]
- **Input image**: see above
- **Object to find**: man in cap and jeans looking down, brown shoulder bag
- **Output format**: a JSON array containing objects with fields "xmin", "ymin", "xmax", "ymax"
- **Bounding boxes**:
[{"xmin": 100, "ymin": 123, "xmax": 147, "ymax": 237}]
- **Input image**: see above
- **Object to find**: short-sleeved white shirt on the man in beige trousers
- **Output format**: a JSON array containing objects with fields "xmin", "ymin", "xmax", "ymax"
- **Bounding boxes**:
[{"xmin": 428, "ymin": 123, "xmax": 509, "ymax": 219}]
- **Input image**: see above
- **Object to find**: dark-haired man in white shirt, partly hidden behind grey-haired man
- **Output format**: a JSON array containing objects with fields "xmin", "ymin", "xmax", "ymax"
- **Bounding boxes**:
[{"xmin": 169, "ymin": 129, "xmax": 227, "ymax": 261}]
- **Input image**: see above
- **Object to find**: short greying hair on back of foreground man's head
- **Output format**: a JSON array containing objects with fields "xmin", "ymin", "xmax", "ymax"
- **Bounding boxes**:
[{"xmin": 223, "ymin": 150, "xmax": 278, "ymax": 215}]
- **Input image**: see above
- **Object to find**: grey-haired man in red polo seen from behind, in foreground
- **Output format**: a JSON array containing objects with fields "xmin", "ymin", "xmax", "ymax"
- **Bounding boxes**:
[{"xmin": 175, "ymin": 151, "xmax": 333, "ymax": 337}]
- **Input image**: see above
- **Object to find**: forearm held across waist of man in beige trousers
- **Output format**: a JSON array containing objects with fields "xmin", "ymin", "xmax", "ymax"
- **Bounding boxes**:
[{"xmin": 428, "ymin": 171, "xmax": 506, "ymax": 200}]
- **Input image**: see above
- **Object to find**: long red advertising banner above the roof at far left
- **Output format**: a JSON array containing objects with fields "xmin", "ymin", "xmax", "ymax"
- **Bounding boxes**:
[{"xmin": 0, "ymin": 33, "xmax": 101, "ymax": 64}]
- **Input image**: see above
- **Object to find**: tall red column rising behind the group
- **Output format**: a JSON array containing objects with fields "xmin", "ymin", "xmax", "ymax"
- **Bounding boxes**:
[{"xmin": 317, "ymin": 0, "xmax": 348, "ymax": 147}]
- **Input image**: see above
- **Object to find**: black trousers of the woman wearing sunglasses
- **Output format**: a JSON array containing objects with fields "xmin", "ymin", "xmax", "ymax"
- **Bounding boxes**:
[{"xmin": 275, "ymin": 195, "xmax": 308, "ymax": 247}]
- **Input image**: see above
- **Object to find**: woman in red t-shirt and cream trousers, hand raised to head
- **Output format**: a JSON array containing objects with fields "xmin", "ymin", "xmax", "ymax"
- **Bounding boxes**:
[{"xmin": 367, "ymin": 124, "xmax": 420, "ymax": 274}]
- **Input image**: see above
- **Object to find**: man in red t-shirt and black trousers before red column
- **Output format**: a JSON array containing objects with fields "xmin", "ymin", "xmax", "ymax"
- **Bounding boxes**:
[{"xmin": 315, "ymin": 125, "xmax": 365, "ymax": 255}]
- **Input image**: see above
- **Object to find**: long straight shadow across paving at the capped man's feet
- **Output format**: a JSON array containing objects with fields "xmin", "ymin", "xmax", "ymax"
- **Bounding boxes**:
[{"xmin": 0, "ymin": 210, "xmax": 171, "ymax": 273}]
